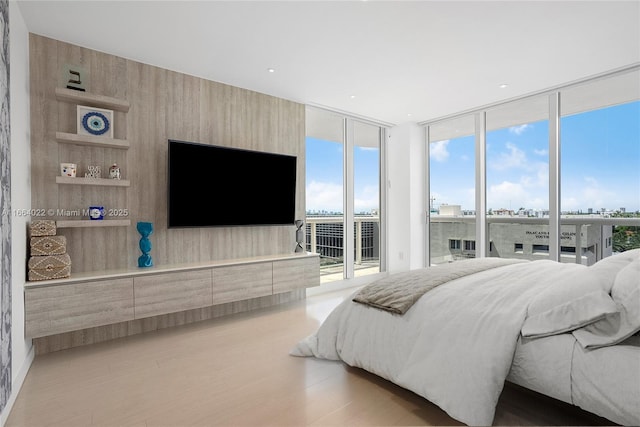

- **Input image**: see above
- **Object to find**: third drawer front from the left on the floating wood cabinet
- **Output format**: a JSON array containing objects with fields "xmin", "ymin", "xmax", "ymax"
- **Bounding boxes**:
[{"xmin": 213, "ymin": 262, "xmax": 273, "ymax": 304}]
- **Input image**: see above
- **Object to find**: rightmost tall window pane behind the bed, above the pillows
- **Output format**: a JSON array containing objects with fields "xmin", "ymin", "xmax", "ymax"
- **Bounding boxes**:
[{"xmin": 560, "ymin": 70, "xmax": 640, "ymax": 264}]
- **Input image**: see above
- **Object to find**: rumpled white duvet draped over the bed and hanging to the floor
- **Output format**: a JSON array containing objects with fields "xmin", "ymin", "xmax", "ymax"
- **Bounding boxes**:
[{"xmin": 290, "ymin": 260, "xmax": 608, "ymax": 425}]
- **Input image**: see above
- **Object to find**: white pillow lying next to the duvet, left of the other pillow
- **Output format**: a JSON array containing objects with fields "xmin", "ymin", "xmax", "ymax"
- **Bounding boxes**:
[{"xmin": 521, "ymin": 264, "xmax": 618, "ymax": 338}]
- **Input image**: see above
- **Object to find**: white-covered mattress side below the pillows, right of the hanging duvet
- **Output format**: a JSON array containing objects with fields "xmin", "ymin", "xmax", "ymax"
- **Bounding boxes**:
[{"xmin": 507, "ymin": 334, "xmax": 640, "ymax": 425}]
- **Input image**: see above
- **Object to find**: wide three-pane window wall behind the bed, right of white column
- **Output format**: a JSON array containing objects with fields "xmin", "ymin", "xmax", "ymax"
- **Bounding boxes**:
[{"xmin": 423, "ymin": 66, "xmax": 640, "ymax": 265}]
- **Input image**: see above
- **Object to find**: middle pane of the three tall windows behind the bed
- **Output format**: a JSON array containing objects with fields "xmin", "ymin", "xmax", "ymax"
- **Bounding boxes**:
[{"xmin": 486, "ymin": 95, "xmax": 549, "ymax": 259}]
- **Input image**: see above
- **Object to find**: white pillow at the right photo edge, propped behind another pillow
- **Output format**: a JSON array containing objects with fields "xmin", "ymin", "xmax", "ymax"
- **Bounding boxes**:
[{"xmin": 572, "ymin": 259, "xmax": 640, "ymax": 348}]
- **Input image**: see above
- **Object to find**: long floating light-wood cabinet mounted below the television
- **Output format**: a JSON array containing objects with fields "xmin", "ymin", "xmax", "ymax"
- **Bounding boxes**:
[{"xmin": 25, "ymin": 254, "xmax": 320, "ymax": 338}]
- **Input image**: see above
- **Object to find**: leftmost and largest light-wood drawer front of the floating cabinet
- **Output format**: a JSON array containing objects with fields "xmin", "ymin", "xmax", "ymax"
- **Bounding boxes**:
[{"xmin": 24, "ymin": 278, "xmax": 133, "ymax": 338}]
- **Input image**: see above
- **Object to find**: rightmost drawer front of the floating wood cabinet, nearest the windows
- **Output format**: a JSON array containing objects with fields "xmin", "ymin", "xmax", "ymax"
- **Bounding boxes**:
[{"xmin": 273, "ymin": 257, "xmax": 320, "ymax": 294}]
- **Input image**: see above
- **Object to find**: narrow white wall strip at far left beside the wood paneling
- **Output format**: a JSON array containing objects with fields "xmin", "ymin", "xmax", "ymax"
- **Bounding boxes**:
[{"xmin": 0, "ymin": 1, "xmax": 33, "ymax": 424}]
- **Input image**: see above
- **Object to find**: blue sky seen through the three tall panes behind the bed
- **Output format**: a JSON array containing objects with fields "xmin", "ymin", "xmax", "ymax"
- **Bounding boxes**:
[{"xmin": 430, "ymin": 102, "xmax": 640, "ymax": 212}]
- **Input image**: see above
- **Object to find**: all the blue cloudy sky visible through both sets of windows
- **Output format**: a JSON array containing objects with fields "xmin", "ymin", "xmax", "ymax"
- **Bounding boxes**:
[{"xmin": 306, "ymin": 102, "xmax": 640, "ymax": 213}]
